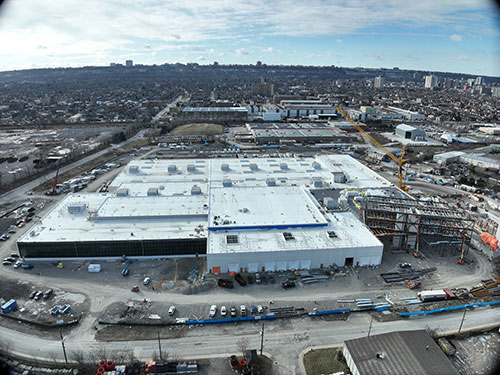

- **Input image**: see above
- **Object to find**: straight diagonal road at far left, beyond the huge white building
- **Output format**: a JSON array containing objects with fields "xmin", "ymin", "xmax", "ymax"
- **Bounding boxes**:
[{"xmin": 0, "ymin": 130, "xmax": 145, "ymax": 204}]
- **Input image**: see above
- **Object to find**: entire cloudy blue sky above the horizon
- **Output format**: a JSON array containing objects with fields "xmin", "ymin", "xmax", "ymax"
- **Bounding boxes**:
[{"xmin": 0, "ymin": 0, "xmax": 500, "ymax": 77}]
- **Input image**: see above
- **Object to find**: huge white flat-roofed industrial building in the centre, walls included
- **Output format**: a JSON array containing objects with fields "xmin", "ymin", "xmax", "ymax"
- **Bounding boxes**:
[{"xmin": 17, "ymin": 155, "xmax": 391, "ymax": 273}]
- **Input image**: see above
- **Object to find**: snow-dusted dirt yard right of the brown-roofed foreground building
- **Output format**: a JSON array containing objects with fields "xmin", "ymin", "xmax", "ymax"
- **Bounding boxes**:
[{"xmin": 450, "ymin": 330, "xmax": 500, "ymax": 375}]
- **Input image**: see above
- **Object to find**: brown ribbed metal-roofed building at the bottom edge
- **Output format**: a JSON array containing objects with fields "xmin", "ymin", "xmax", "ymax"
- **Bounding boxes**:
[{"xmin": 343, "ymin": 330, "xmax": 459, "ymax": 375}]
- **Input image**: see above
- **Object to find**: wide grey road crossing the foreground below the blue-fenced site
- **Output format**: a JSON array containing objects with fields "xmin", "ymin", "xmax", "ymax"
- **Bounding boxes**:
[{"xmin": 0, "ymin": 308, "xmax": 500, "ymax": 374}]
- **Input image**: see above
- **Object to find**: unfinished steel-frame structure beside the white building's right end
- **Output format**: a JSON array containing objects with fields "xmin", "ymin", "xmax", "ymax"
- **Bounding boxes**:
[{"xmin": 362, "ymin": 195, "xmax": 474, "ymax": 258}]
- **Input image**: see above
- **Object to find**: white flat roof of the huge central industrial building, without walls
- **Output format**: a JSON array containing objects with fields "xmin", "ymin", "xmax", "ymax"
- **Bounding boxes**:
[{"xmin": 19, "ymin": 155, "xmax": 392, "ymax": 252}]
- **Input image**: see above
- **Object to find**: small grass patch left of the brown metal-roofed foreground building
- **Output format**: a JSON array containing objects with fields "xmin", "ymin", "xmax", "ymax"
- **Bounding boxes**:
[{"xmin": 304, "ymin": 348, "xmax": 348, "ymax": 375}]
